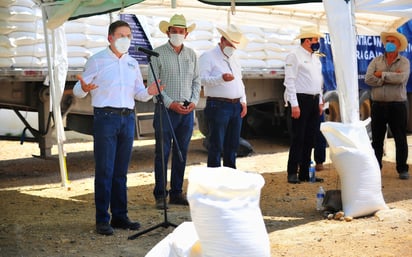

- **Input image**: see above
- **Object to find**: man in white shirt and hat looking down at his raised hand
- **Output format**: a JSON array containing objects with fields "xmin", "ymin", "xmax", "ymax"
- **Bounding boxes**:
[{"xmin": 199, "ymin": 25, "xmax": 247, "ymax": 169}]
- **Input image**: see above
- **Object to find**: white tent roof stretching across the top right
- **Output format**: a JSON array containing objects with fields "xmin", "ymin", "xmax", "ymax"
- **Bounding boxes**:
[{"xmin": 124, "ymin": 0, "xmax": 412, "ymax": 35}]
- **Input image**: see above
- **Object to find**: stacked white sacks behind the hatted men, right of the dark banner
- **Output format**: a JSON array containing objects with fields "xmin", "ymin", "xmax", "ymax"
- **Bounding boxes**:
[{"xmin": 146, "ymin": 17, "xmax": 299, "ymax": 69}]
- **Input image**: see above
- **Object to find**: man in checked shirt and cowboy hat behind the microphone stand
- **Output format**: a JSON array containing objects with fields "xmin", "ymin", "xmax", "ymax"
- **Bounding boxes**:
[{"xmin": 148, "ymin": 14, "xmax": 200, "ymax": 209}]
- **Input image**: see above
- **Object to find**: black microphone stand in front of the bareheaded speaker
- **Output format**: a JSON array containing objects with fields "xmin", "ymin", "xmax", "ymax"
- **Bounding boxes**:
[{"xmin": 128, "ymin": 51, "xmax": 183, "ymax": 240}]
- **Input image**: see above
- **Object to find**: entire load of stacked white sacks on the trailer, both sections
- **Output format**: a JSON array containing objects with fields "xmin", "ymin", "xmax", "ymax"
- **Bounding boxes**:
[{"xmin": 0, "ymin": 0, "xmax": 299, "ymax": 69}]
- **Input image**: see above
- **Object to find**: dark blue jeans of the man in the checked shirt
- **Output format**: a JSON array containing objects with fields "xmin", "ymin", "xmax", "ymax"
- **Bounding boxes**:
[{"xmin": 153, "ymin": 104, "xmax": 194, "ymax": 199}]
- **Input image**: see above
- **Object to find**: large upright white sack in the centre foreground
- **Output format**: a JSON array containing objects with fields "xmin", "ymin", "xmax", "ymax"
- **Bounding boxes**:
[{"xmin": 187, "ymin": 167, "xmax": 270, "ymax": 257}]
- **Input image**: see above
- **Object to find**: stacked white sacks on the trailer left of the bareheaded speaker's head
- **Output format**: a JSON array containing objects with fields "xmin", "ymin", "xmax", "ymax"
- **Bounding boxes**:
[{"xmin": 0, "ymin": 0, "xmax": 110, "ymax": 68}]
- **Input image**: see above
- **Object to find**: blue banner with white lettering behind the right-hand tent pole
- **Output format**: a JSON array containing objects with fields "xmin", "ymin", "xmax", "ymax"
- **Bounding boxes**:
[{"xmin": 320, "ymin": 20, "xmax": 412, "ymax": 92}]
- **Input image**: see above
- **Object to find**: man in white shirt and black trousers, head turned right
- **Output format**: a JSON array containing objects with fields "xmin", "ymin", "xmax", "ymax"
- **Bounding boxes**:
[{"xmin": 284, "ymin": 26, "xmax": 323, "ymax": 184}]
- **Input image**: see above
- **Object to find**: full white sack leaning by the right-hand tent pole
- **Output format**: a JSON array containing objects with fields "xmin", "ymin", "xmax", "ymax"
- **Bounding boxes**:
[{"xmin": 321, "ymin": 119, "xmax": 388, "ymax": 217}]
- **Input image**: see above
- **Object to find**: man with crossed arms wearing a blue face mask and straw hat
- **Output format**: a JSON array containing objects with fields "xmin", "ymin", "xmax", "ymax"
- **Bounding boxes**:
[{"xmin": 365, "ymin": 31, "xmax": 410, "ymax": 179}]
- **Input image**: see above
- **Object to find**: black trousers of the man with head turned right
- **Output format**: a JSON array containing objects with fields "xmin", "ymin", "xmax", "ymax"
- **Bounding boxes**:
[{"xmin": 287, "ymin": 94, "xmax": 320, "ymax": 180}]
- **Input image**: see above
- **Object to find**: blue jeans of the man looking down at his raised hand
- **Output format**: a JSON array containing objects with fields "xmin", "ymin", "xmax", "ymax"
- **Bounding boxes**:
[{"xmin": 204, "ymin": 100, "xmax": 242, "ymax": 169}]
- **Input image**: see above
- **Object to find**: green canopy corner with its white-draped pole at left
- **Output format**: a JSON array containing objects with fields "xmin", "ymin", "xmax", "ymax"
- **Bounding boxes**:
[{"xmin": 37, "ymin": 0, "xmax": 142, "ymax": 187}]
